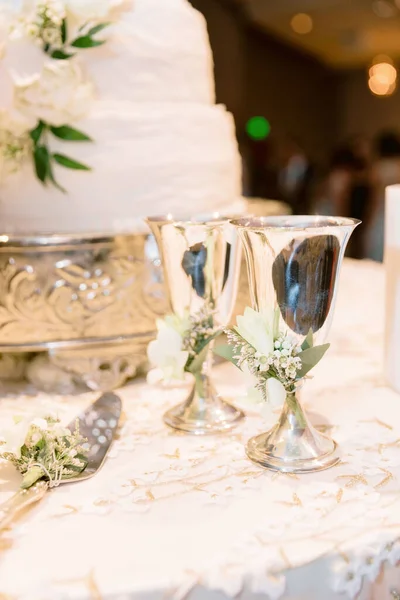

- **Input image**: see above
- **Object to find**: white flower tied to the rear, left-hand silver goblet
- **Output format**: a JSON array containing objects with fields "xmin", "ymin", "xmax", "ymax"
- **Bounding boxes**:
[{"xmin": 147, "ymin": 321, "xmax": 189, "ymax": 384}]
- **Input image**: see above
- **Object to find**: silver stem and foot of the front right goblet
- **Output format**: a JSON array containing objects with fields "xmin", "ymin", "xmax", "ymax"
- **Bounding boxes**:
[{"xmin": 246, "ymin": 390, "xmax": 340, "ymax": 473}]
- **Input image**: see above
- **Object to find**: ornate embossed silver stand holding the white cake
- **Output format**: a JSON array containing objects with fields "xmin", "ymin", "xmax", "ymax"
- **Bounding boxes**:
[{"xmin": 0, "ymin": 234, "xmax": 167, "ymax": 390}]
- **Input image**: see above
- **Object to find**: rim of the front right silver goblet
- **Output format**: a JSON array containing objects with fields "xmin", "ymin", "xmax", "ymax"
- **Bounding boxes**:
[{"xmin": 230, "ymin": 215, "xmax": 361, "ymax": 231}]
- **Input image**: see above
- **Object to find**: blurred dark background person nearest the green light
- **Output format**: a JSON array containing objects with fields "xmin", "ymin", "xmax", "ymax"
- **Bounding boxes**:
[{"xmin": 278, "ymin": 136, "xmax": 314, "ymax": 215}]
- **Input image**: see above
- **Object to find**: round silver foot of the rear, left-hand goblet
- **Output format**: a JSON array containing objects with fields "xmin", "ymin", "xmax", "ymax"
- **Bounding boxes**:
[{"xmin": 164, "ymin": 376, "xmax": 244, "ymax": 435}]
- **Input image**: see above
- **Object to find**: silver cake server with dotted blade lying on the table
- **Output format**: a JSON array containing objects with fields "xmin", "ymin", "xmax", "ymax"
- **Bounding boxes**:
[{"xmin": 0, "ymin": 392, "xmax": 122, "ymax": 530}]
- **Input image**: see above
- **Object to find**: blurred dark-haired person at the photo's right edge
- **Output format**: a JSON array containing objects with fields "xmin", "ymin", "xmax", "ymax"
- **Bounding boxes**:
[{"xmin": 365, "ymin": 131, "xmax": 400, "ymax": 261}]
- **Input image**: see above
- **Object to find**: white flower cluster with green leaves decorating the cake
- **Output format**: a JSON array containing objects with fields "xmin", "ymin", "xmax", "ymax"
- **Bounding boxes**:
[{"xmin": 0, "ymin": 0, "xmax": 129, "ymax": 192}]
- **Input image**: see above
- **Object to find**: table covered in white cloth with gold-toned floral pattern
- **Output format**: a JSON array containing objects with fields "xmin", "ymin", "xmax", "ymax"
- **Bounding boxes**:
[{"xmin": 0, "ymin": 261, "xmax": 400, "ymax": 600}]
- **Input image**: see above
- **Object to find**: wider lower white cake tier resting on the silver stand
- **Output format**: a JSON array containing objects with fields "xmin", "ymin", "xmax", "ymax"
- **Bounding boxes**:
[{"xmin": 0, "ymin": 102, "xmax": 240, "ymax": 233}]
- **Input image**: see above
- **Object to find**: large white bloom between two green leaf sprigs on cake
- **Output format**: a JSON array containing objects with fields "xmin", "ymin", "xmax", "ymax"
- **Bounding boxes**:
[{"xmin": 15, "ymin": 60, "xmax": 94, "ymax": 127}]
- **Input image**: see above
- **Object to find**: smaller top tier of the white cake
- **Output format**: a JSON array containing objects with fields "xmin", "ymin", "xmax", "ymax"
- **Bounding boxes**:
[{"xmin": 82, "ymin": 0, "xmax": 215, "ymax": 104}]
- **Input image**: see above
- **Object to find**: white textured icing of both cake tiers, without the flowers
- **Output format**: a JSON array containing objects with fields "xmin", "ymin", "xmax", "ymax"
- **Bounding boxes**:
[{"xmin": 0, "ymin": 0, "xmax": 241, "ymax": 232}]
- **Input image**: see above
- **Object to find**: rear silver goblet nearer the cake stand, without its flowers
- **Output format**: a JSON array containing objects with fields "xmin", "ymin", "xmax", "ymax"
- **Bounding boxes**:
[{"xmin": 147, "ymin": 215, "xmax": 244, "ymax": 435}]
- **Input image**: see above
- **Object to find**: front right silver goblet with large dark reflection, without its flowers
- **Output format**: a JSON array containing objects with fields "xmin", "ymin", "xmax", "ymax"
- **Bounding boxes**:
[{"xmin": 232, "ymin": 216, "xmax": 359, "ymax": 473}]
